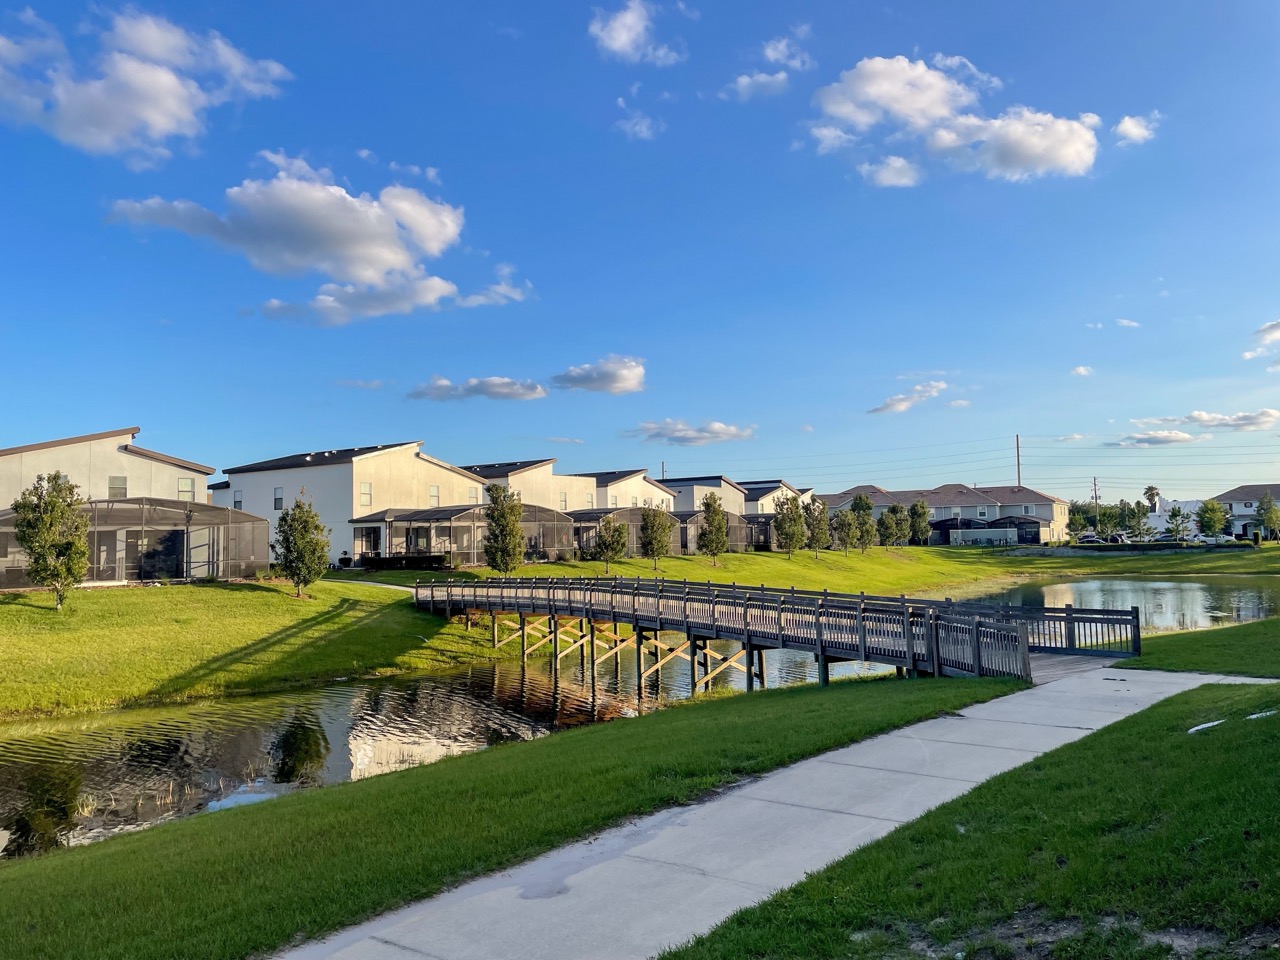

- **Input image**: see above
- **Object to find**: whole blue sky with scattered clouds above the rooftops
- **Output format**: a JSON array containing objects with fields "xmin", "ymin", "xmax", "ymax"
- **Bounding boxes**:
[{"xmin": 0, "ymin": 0, "xmax": 1280, "ymax": 499}]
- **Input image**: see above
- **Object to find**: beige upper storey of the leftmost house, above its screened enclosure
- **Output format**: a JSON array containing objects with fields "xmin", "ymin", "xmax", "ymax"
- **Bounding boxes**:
[{"xmin": 0, "ymin": 426, "xmax": 215, "ymax": 507}]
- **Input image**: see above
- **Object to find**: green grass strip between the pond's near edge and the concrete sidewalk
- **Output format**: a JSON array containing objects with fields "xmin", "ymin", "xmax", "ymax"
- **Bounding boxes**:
[{"xmin": 0, "ymin": 680, "xmax": 1020, "ymax": 960}]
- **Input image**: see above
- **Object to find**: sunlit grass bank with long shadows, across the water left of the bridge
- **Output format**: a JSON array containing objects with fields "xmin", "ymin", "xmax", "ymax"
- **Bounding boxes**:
[{"xmin": 0, "ymin": 582, "xmax": 509, "ymax": 719}]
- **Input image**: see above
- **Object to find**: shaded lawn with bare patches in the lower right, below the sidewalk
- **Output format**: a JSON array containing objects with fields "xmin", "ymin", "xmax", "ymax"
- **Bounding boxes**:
[{"xmin": 664, "ymin": 686, "xmax": 1280, "ymax": 960}]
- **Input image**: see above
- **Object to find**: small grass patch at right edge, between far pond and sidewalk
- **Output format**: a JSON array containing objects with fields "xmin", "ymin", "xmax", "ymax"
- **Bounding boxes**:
[{"xmin": 1116, "ymin": 620, "xmax": 1280, "ymax": 677}]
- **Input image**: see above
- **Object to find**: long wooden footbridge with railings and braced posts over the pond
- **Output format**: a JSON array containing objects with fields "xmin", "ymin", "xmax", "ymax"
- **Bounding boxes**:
[{"xmin": 413, "ymin": 577, "xmax": 1142, "ymax": 690}]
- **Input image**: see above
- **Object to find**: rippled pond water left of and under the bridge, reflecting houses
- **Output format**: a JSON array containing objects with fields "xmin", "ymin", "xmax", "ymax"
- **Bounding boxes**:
[{"xmin": 0, "ymin": 644, "xmax": 878, "ymax": 858}]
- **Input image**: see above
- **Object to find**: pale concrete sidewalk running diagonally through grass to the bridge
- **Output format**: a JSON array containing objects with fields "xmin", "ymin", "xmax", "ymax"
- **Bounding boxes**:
[{"xmin": 283, "ymin": 667, "xmax": 1270, "ymax": 960}]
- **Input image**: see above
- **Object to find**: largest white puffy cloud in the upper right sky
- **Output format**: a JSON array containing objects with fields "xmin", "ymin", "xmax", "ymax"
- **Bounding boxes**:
[{"xmin": 812, "ymin": 55, "xmax": 1101, "ymax": 182}]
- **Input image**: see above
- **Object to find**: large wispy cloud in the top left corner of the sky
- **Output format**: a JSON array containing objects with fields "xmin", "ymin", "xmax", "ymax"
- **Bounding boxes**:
[{"xmin": 0, "ymin": 8, "xmax": 291, "ymax": 169}]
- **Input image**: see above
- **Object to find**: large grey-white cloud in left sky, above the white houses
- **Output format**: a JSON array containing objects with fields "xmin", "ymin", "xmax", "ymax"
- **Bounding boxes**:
[{"xmin": 111, "ymin": 150, "xmax": 512, "ymax": 324}]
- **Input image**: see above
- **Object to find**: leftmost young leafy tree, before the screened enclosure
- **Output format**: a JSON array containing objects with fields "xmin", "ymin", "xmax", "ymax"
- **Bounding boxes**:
[{"xmin": 13, "ymin": 471, "xmax": 88, "ymax": 611}]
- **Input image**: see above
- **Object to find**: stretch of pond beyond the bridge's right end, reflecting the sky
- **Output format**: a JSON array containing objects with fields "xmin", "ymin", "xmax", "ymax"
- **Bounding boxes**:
[{"xmin": 973, "ymin": 576, "xmax": 1280, "ymax": 632}]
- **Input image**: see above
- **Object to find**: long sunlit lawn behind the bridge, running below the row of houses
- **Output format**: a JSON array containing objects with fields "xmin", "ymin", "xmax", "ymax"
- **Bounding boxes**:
[{"xmin": 330, "ymin": 545, "xmax": 1280, "ymax": 596}]
